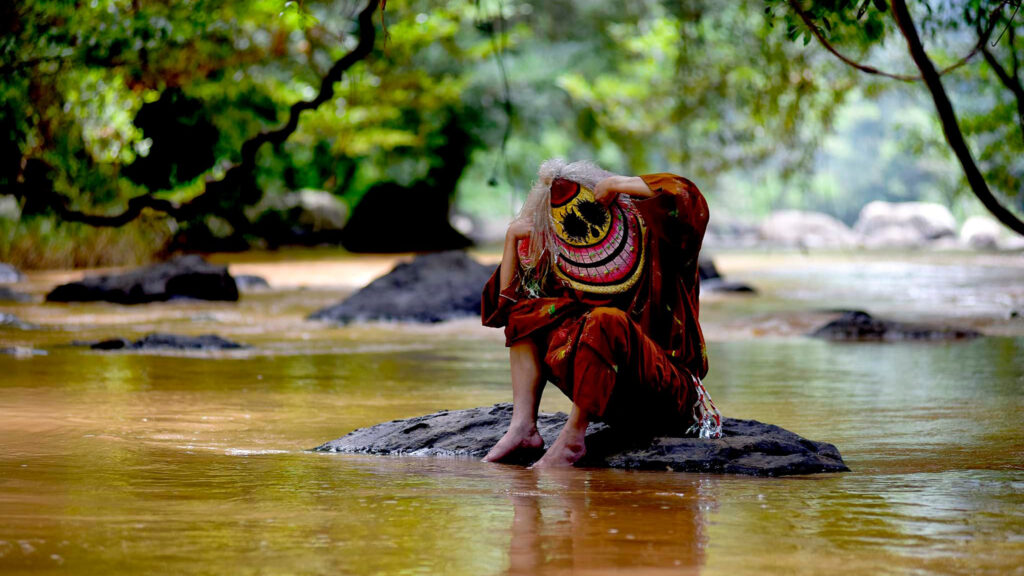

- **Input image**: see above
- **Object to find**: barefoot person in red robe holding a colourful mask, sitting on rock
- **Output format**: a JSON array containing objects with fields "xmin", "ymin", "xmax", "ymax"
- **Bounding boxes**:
[{"xmin": 481, "ymin": 159, "xmax": 721, "ymax": 467}]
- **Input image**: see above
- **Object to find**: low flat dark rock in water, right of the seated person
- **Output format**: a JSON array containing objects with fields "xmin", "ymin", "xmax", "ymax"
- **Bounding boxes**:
[{"xmin": 810, "ymin": 311, "xmax": 983, "ymax": 341}]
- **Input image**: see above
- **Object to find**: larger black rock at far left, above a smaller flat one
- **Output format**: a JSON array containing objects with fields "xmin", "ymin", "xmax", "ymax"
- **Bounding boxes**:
[{"xmin": 46, "ymin": 255, "xmax": 239, "ymax": 304}]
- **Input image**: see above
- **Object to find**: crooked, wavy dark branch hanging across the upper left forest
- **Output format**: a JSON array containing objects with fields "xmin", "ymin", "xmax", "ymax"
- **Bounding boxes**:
[{"xmin": 37, "ymin": 0, "xmax": 378, "ymax": 227}]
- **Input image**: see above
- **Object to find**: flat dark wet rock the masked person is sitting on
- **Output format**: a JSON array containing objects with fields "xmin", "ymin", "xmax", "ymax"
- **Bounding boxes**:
[{"xmin": 314, "ymin": 404, "xmax": 849, "ymax": 476}]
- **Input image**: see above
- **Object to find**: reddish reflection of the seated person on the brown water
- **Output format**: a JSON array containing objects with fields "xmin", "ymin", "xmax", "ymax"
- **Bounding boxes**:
[{"xmin": 508, "ymin": 470, "xmax": 714, "ymax": 576}]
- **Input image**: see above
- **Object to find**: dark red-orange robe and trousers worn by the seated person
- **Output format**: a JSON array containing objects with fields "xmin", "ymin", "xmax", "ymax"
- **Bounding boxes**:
[{"xmin": 481, "ymin": 173, "xmax": 708, "ymax": 431}]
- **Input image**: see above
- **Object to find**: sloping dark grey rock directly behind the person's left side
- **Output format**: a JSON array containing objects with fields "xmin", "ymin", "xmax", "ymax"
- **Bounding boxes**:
[{"xmin": 309, "ymin": 251, "xmax": 494, "ymax": 324}]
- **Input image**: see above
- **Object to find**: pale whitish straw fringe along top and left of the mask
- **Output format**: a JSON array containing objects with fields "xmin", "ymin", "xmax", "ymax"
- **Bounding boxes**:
[{"xmin": 516, "ymin": 158, "xmax": 629, "ymax": 280}]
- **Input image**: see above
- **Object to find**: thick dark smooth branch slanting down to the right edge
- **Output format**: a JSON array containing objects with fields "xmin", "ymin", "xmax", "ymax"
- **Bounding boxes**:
[{"xmin": 891, "ymin": 0, "xmax": 1024, "ymax": 236}]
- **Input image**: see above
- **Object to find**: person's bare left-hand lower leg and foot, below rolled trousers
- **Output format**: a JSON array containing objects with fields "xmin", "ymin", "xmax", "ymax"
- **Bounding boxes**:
[{"xmin": 483, "ymin": 338, "xmax": 544, "ymax": 462}]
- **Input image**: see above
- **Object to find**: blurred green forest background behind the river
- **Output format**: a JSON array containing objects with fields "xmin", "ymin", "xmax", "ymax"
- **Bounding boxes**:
[{"xmin": 0, "ymin": 0, "xmax": 1024, "ymax": 268}]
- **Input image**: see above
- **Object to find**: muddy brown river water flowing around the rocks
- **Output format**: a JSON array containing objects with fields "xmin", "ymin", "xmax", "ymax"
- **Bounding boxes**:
[{"xmin": 0, "ymin": 251, "xmax": 1024, "ymax": 575}]
